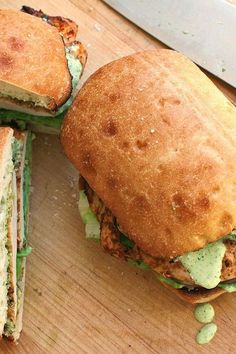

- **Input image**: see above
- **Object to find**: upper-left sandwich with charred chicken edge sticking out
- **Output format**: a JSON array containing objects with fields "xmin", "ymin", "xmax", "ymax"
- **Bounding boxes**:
[{"xmin": 0, "ymin": 6, "xmax": 87, "ymax": 133}]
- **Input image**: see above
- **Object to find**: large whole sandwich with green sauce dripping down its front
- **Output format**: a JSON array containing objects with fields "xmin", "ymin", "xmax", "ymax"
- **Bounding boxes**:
[{"xmin": 61, "ymin": 49, "xmax": 236, "ymax": 303}]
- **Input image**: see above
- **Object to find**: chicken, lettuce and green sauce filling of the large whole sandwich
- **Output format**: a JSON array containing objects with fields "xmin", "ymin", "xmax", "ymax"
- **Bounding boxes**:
[{"xmin": 79, "ymin": 177, "xmax": 236, "ymax": 292}]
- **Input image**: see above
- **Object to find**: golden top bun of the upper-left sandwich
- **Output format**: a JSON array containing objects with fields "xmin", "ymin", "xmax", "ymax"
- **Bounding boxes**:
[{"xmin": 0, "ymin": 9, "xmax": 72, "ymax": 110}]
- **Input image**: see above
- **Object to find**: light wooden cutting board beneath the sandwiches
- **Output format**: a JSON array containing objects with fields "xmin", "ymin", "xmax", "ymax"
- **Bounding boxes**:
[{"xmin": 0, "ymin": 0, "xmax": 236, "ymax": 354}]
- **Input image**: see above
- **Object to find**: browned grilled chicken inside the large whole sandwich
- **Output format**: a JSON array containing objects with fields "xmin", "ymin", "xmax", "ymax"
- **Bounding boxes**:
[{"xmin": 79, "ymin": 177, "xmax": 236, "ymax": 285}]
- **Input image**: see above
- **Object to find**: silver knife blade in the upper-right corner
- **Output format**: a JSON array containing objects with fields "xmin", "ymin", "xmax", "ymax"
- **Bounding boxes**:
[{"xmin": 104, "ymin": 0, "xmax": 236, "ymax": 88}]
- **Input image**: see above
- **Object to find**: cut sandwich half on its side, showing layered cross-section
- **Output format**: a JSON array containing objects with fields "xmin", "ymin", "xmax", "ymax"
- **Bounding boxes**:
[{"xmin": 0, "ymin": 127, "xmax": 32, "ymax": 341}]
